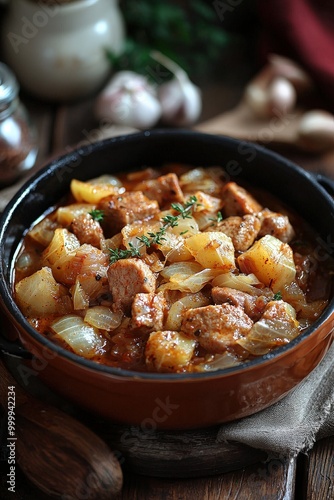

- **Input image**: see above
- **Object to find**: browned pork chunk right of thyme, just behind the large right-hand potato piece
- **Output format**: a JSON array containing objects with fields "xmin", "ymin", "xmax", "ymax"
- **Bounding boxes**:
[{"xmin": 216, "ymin": 214, "xmax": 261, "ymax": 252}]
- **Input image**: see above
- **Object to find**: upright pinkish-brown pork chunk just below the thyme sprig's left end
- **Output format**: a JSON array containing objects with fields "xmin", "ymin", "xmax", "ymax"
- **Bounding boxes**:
[{"xmin": 108, "ymin": 259, "xmax": 156, "ymax": 313}]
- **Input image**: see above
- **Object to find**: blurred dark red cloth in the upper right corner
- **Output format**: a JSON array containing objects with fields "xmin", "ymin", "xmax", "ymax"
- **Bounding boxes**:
[{"xmin": 258, "ymin": 0, "xmax": 334, "ymax": 112}]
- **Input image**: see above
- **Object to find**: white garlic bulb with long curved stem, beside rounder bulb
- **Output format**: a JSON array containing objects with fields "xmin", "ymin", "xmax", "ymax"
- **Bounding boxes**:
[{"xmin": 151, "ymin": 51, "xmax": 202, "ymax": 127}]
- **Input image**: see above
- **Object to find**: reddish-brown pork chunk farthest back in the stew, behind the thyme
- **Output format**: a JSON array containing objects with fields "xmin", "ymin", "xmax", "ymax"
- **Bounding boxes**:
[{"xmin": 136, "ymin": 173, "xmax": 184, "ymax": 208}]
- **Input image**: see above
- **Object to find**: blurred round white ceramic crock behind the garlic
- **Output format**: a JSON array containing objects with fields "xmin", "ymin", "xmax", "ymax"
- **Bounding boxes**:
[{"xmin": 2, "ymin": 0, "xmax": 124, "ymax": 101}]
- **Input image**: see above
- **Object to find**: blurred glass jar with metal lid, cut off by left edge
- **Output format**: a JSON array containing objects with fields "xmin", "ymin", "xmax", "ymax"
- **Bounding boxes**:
[{"xmin": 0, "ymin": 63, "xmax": 38, "ymax": 185}]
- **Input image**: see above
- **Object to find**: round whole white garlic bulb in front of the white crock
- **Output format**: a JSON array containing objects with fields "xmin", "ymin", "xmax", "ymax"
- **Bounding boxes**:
[{"xmin": 95, "ymin": 71, "xmax": 161, "ymax": 129}]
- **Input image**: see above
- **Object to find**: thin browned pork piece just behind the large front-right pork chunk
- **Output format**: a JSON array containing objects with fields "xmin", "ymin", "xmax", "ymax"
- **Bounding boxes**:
[{"xmin": 211, "ymin": 286, "xmax": 270, "ymax": 321}]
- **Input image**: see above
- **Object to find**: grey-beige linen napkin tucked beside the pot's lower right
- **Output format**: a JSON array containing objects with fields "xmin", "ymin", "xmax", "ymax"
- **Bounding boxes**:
[{"xmin": 217, "ymin": 344, "xmax": 334, "ymax": 457}]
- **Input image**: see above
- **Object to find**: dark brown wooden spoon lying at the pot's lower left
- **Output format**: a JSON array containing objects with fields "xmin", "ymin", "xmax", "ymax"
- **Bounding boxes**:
[{"xmin": 0, "ymin": 360, "xmax": 123, "ymax": 500}]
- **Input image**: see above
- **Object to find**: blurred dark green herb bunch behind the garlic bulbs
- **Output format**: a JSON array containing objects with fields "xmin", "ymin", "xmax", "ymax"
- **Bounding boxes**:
[{"xmin": 108, "ymin": 0, "xmax": 233, "ymax": 83}]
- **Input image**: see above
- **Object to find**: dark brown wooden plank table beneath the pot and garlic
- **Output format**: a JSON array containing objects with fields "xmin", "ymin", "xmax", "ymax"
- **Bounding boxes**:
[{"xmin": 0, "ymin": 65, "xmax": 334, "ymax": 500}]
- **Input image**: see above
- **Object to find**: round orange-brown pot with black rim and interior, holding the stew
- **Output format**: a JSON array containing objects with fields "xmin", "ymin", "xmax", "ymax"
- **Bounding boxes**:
[{"xmin": 0, "ymin": 130, "xmax": 334, "ymax": 429}]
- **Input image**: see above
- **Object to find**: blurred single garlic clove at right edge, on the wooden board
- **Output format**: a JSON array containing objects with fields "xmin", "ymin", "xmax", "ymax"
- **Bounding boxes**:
[{"xmin": 297, "ymin": 109, "xmax": 334, "ymax": 151}]
